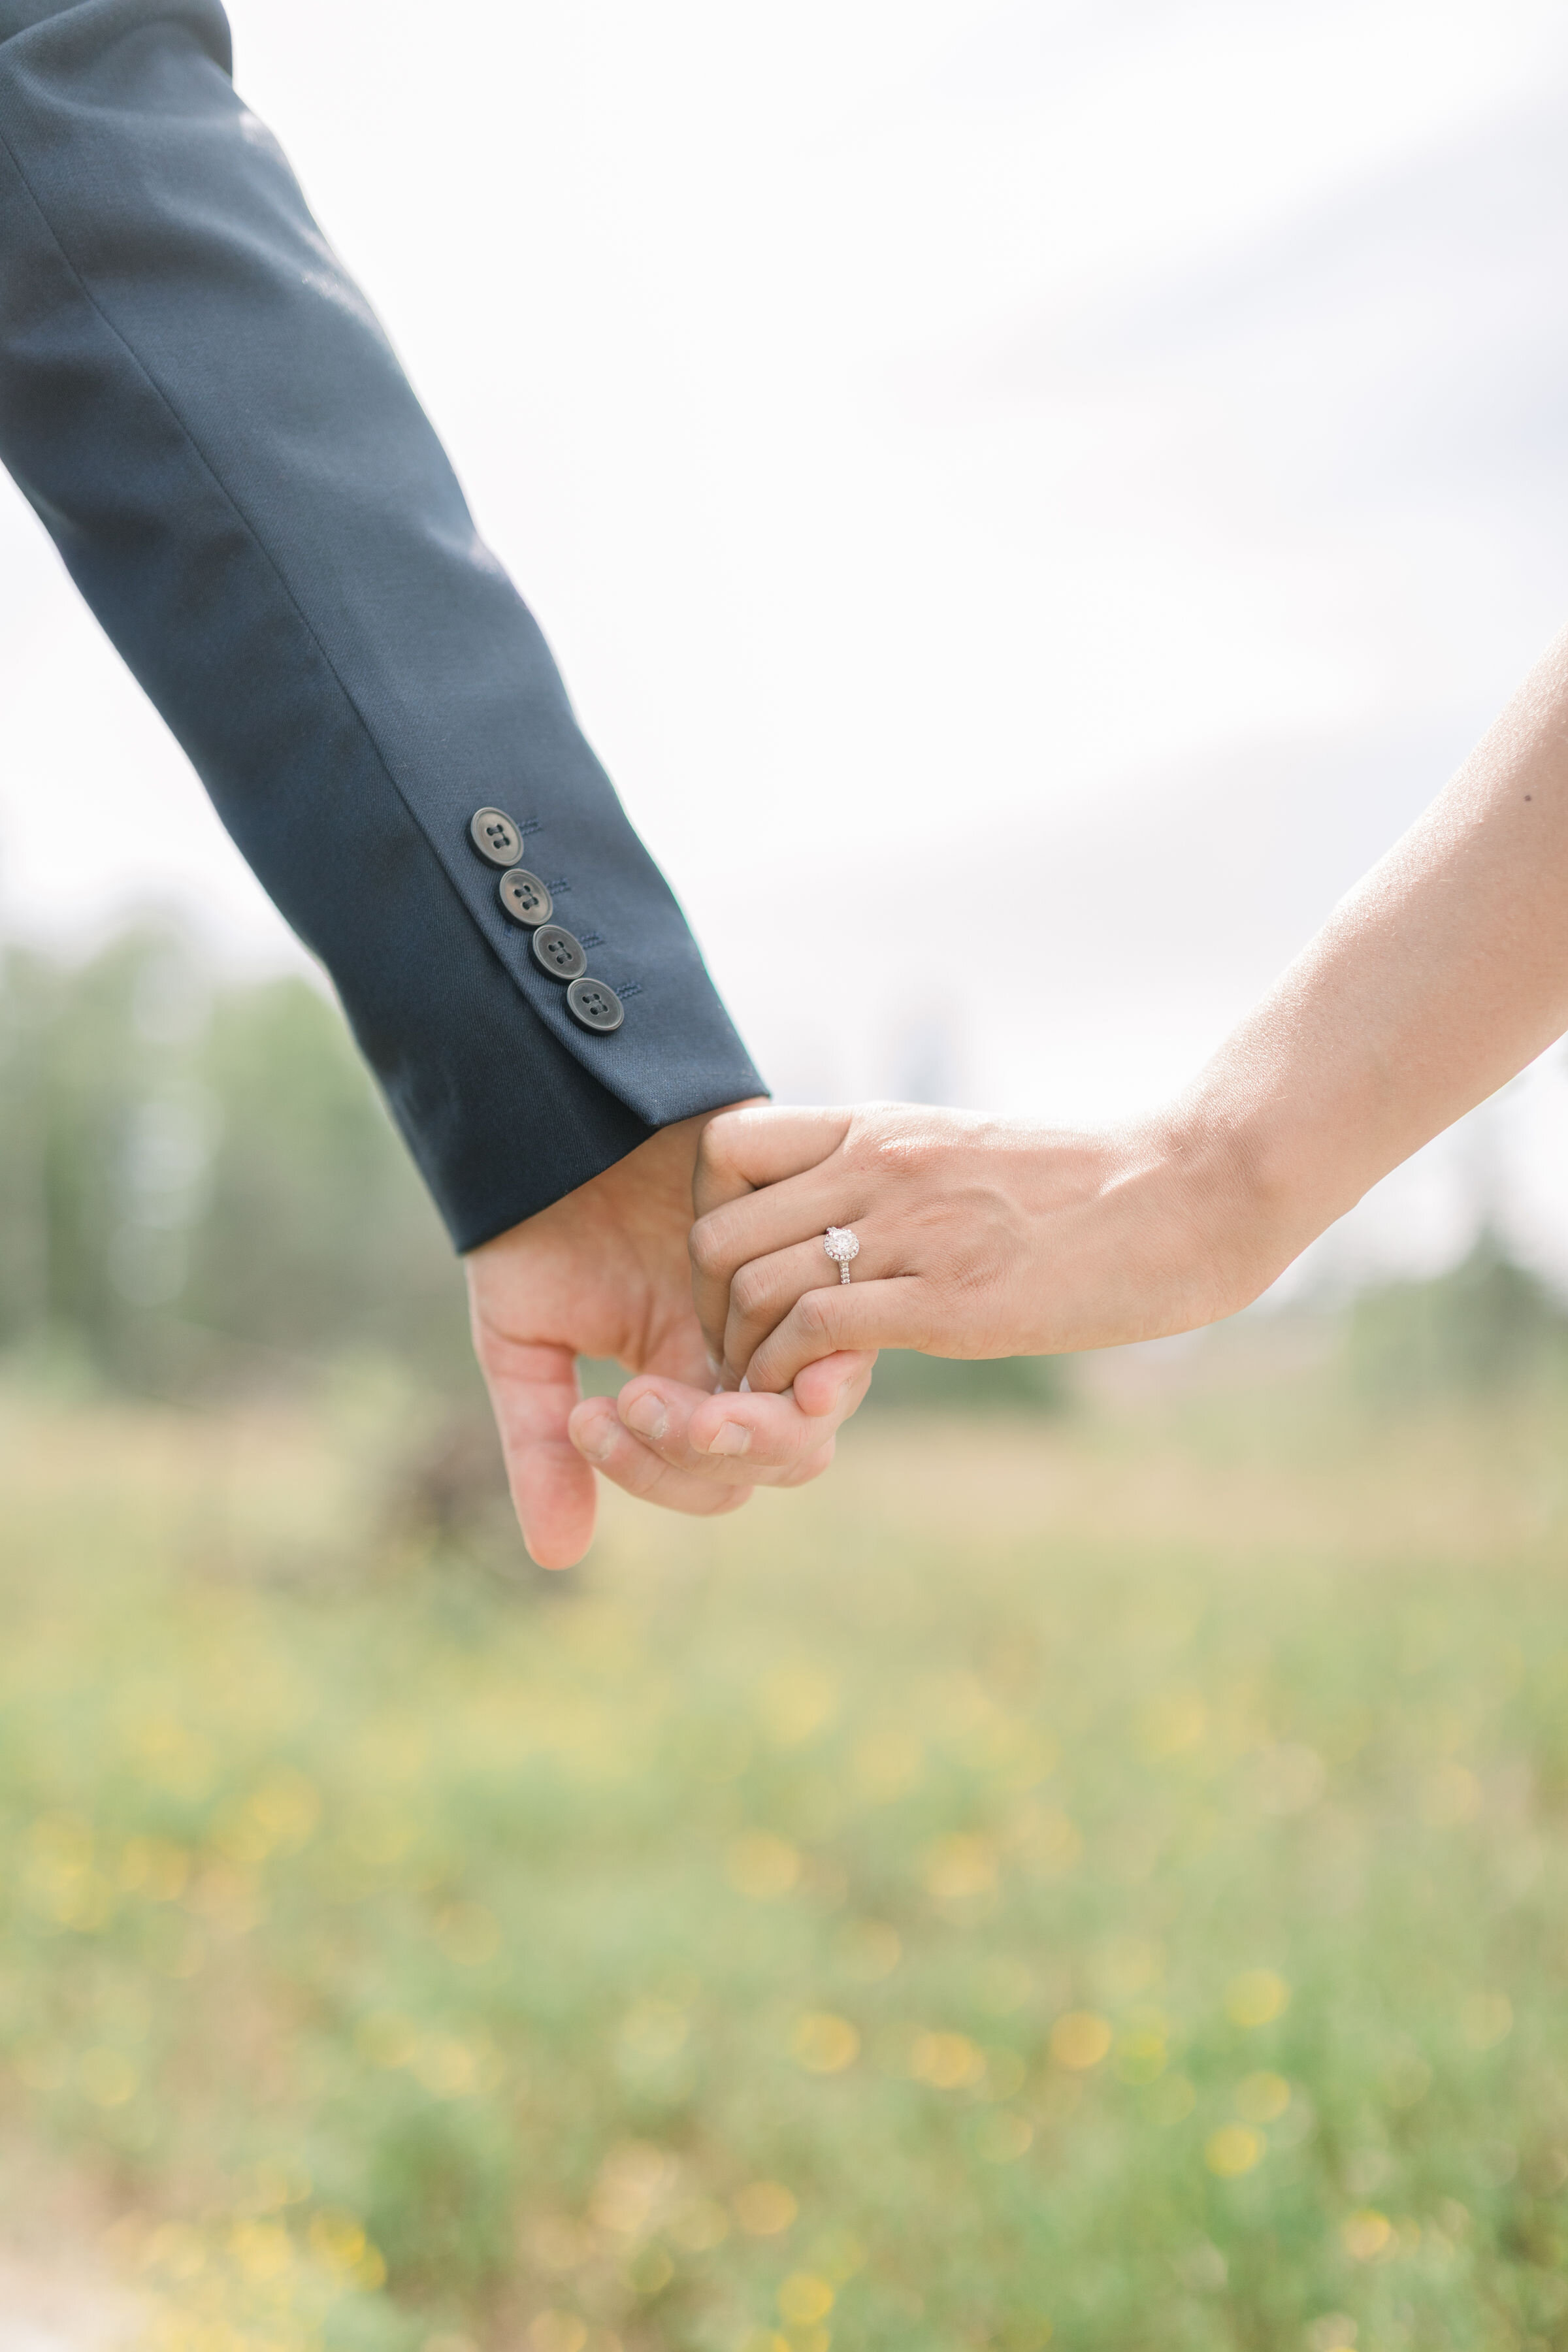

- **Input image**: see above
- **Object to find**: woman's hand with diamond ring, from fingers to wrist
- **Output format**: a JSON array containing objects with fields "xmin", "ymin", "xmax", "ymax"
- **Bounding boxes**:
[{"xmin": 691, "ymin": 1103, "xmax": 1290, "ymax": 1390}]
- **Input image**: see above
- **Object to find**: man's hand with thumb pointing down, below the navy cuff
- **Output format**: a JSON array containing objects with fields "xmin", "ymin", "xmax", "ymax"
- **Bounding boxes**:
[{"xmin": 465, "ymin": 1117, "xmax": 875, "ymax": 1569}]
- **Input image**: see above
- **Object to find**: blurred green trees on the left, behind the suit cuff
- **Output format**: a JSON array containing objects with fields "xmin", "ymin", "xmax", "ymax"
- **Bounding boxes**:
[{"xmin": 0, "ymin": 929, "xmax": 465, "ymax": 1392}]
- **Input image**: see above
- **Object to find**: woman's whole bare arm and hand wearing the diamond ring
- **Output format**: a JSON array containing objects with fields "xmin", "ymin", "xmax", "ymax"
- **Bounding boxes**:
[{"xmin": 691, "ymin": 616, "xmax": 1568, "ymax": 1401}]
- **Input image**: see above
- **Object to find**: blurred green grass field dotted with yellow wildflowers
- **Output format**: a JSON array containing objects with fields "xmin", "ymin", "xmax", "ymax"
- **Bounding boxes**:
[{"xmin": 0, "ymin": 1376, "xmax": 1568, "ymax": 2352}]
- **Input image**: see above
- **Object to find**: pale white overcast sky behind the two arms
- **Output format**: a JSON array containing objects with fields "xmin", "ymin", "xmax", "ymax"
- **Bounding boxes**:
[{"xmin": 0, "ymin": 0, "xmax": 1568, "ymax": 1270}]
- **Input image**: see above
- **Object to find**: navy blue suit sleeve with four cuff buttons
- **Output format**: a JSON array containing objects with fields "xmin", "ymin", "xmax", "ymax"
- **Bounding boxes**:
[{"xmin": 0, "ymin": 0, "xmax": 762, "ymax": 1249}]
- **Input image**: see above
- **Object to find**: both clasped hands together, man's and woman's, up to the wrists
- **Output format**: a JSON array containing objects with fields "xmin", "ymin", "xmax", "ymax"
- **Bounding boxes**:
[{"xmin": 465, "ymin": 1103, "xmax": 1290, "ymax": 1569}]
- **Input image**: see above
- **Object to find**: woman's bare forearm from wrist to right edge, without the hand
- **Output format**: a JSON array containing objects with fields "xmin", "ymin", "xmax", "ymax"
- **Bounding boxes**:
[{"xmin": 1178, "ymin": 621, "xmax": 1568, "ymax": 1266}]
